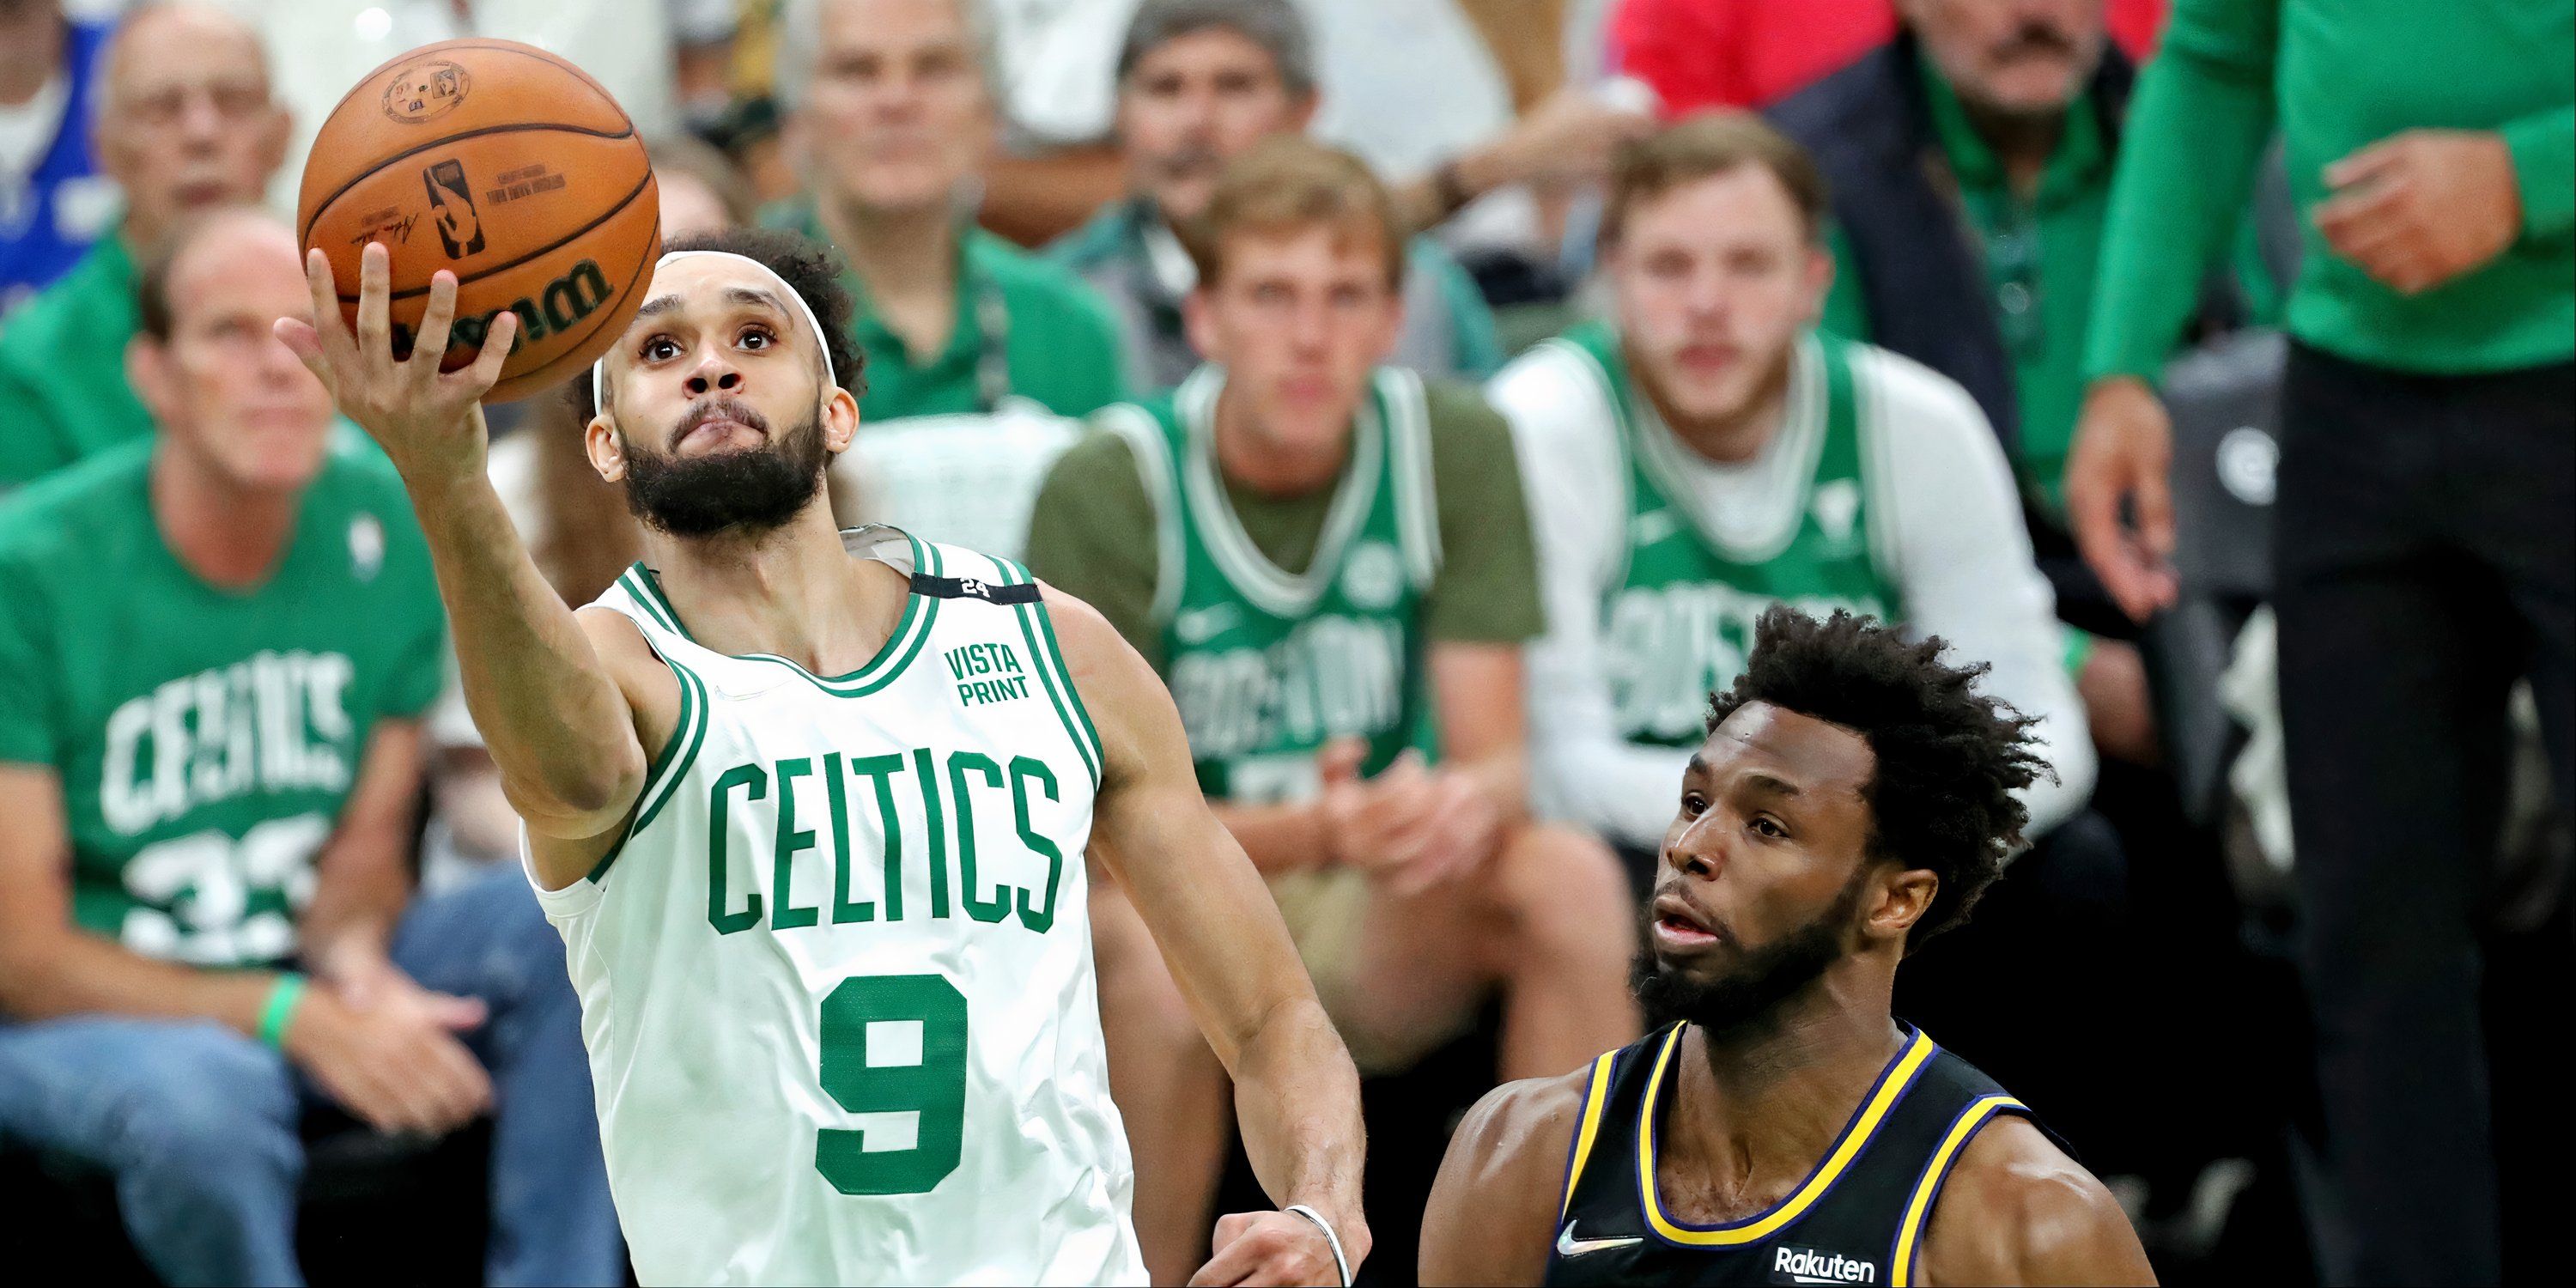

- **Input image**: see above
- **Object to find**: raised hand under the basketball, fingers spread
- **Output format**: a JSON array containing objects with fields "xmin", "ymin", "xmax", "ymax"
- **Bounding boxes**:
[{"xmin": 276, "ymin": 242, "xmax": 518, "ymax": 479}]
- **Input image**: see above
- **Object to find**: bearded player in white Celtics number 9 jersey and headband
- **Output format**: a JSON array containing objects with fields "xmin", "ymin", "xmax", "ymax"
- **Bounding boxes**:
[{"xmin": 278, "ymin": 232, "xmax": 1368, "ymax": 1283}]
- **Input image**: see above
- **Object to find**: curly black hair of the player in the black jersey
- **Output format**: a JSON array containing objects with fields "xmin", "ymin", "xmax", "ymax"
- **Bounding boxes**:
[{"xmin": 1708, "ymin": 605, "xmax": 2056, "ymax": 953}]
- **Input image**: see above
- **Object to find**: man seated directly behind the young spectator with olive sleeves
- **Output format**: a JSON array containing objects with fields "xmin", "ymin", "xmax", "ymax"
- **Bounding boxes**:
[{"xmin": 1048, "ymin": 0, "xmax": 1502, "ymax": 389}]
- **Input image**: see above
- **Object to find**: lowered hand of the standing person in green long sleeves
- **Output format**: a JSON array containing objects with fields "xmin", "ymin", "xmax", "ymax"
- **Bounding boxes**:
[{"xmin": 2066, "ymin": 376, "xmax": 2182, "ymax": 621}]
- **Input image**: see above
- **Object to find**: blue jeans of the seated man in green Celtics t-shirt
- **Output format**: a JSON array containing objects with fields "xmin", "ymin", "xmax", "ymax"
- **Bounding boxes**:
[{"xmin": 0, "ymin": 866, "xmax": 626, "ymax": 1285}]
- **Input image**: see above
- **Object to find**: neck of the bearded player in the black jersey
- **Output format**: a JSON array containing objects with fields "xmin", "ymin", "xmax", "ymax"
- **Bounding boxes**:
[{"xmin": 1669, "ymin": 969, "xmax": 1904, "ymax": 1211}]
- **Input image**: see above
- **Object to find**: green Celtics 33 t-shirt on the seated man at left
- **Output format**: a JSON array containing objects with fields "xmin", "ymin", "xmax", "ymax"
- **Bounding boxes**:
[{"xmin": 0, "ymin": 443, "xmax": 446, "ymax": 966}]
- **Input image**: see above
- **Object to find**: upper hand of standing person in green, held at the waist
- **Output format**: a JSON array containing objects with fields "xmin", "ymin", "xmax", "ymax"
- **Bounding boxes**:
[{"xmin": 2313, "ymin": 129, "xmax": 2522, "ymax": 296}]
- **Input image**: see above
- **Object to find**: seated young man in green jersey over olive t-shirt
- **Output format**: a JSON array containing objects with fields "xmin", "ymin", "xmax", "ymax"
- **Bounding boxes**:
[{"xmin": 1028, "ymin": 137, "xmax": 1636, "ymax": 1270}]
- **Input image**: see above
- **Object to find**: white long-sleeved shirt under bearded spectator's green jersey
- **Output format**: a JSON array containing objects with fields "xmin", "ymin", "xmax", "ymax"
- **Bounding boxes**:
[{"xmin": 1486, "ymin": 345, "xmax": 2094, "ymax": 848}]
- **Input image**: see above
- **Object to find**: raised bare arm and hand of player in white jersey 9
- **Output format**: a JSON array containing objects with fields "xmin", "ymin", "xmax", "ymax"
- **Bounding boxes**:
[{"xmin": 276, "ymin": 245, "xmax": 677, "ymax": 886}]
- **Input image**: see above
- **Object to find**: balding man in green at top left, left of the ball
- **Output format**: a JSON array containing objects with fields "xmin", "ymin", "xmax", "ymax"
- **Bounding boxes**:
[{"xmin": 0, "ymin": 5, "xmax": 286, "ymax": 495}]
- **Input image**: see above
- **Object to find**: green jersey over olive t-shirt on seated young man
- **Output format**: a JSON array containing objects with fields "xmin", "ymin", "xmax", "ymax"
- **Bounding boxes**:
[{"xmin": 1028, "ymin": 368, "xmax": 1546, "ymax": 799}]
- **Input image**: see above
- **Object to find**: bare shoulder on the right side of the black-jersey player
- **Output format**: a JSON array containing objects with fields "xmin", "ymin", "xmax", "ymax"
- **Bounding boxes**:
[{"xmin": 1922, "ymin": 1118, "xmax": 2156, "ymax": 1283}]
